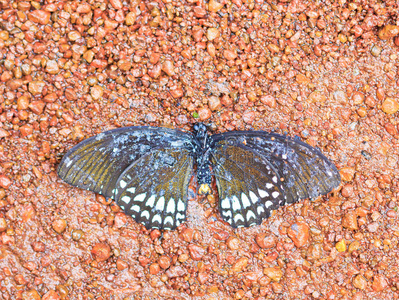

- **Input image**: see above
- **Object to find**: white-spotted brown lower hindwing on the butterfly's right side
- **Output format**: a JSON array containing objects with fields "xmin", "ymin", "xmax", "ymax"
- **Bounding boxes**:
[{"xmin": 211, "ymin": 142, "xmax": 284, "ymax": 227}]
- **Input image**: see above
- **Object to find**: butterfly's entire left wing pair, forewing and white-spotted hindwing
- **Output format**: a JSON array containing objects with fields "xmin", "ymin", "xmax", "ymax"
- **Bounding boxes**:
[{"xmin": 58, "ymin": 127, "xmax": 193, "ymax": 229}]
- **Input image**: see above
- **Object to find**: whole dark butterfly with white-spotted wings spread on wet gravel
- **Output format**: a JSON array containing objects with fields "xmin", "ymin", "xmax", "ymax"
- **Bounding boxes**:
[{"xmin": 57, "ymin": 123, "xmax": 341, "ymax": 230}]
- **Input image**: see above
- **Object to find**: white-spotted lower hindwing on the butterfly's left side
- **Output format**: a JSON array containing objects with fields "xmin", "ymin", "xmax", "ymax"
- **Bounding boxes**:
[{"xmin": 114, "ymin": 149, "xmax": 193, "ymax": 229}]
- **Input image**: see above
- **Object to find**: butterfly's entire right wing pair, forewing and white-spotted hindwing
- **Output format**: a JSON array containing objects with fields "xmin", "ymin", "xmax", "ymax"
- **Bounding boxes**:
[{"xmin": 211, "ymin": 131, "xmax": 341, "ymax": 227}]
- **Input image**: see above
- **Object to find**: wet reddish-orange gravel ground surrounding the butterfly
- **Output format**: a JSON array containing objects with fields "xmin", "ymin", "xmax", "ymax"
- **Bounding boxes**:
[{"xmin": 0, "ymin": 0, "xmax": 399, "ymax": 300}]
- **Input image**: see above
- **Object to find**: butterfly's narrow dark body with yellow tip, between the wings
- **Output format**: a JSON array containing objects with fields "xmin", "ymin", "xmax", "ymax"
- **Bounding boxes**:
[{"xmin": 194, "ymin": 123, "xmax": 212, "ymax": 194}]
